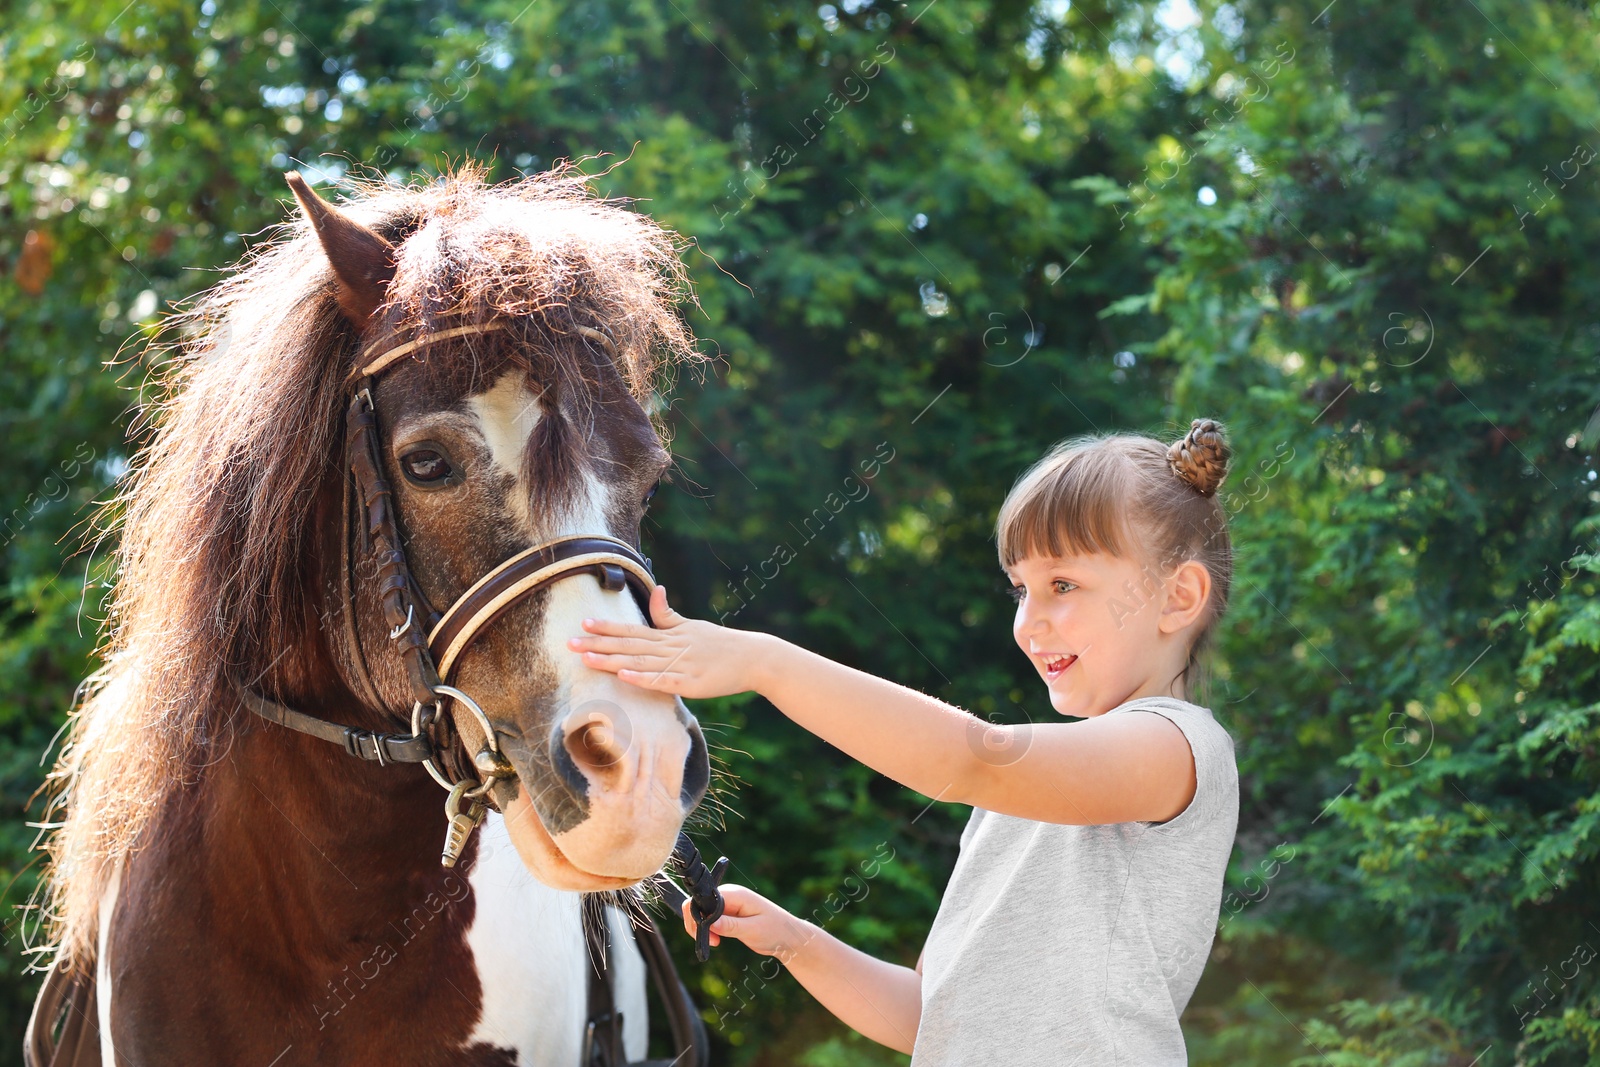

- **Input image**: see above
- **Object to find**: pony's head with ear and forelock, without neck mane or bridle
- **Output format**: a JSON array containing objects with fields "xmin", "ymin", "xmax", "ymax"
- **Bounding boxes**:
[{"xmin": 290, "ymin": 167, "xmax": 709, "ymax": 889}]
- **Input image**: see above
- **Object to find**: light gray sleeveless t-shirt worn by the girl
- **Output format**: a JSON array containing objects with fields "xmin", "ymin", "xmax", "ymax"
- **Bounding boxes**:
[{"xmin": 910, "ymin": 697, "xmax": 1238, "ymax": 1067}]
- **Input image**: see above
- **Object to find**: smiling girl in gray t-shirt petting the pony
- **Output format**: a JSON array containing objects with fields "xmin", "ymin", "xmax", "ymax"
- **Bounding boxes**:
[{"xmin": 571, "ymin": 419, "xmax": 1238, "ymax": 1067}]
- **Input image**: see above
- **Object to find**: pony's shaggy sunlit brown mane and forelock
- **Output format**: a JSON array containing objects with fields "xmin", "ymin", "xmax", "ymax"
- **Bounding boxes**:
[{"xmin": 32, "ymin": 166, "xmax": 698, "ymax": 969}]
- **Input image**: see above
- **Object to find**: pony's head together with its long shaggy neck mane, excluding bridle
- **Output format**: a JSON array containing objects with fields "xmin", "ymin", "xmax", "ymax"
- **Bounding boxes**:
[{"xmin": 46, "ymin": 168, "xmax": 709, "ymax": 965}]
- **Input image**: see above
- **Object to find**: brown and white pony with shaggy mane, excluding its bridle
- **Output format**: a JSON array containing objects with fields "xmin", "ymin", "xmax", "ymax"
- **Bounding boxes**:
[{"xmin": 23, "ymin": 168, "xmax": 707, "ymax": 1067}]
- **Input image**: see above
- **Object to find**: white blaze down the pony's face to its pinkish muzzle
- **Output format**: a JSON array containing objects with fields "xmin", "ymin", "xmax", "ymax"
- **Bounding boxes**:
[{"xmin": 470, "ymin": 371, "xmax": 690, "ymax": 880}]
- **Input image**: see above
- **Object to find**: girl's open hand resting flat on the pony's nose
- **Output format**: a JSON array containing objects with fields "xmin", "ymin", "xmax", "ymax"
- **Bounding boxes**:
[{"xmin": 566, "ymin": 585, "xmax": 763, "ymax": 699}]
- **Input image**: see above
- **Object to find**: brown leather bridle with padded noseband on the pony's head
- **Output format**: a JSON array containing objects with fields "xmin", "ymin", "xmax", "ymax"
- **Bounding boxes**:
[{"xmin": 240, "ymin": 322, "xmax": 656, "ymax": 867}]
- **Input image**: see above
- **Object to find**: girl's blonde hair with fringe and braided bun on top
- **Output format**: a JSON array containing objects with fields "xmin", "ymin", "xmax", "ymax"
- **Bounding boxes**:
[{"xmin": 995, "ymin": 419, "xmax": 1234, "ymax": 702}]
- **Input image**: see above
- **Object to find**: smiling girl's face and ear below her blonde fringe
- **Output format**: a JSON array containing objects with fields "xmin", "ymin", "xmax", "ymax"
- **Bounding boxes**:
[{"xmin": 1006, "ymin": 553, "xmax": 1210, "ymax": 718}]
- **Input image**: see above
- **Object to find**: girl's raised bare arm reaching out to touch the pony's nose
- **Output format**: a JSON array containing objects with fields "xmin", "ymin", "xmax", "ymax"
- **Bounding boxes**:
[{"xmin": 570, "ymin": 587, "xmax": 1195, "ymax": 825}]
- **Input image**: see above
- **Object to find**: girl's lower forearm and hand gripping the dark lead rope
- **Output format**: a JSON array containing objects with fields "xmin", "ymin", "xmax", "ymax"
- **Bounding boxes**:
[{"xmin": 683, "ymin": 885, "xmax": 922, "ymax": 1054}]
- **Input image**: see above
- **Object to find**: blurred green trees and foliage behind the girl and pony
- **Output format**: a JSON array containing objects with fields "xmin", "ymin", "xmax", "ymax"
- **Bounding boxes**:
[{"xmin": 0, "ymin": 0, "xmax": 1600, "ymax": 1067}]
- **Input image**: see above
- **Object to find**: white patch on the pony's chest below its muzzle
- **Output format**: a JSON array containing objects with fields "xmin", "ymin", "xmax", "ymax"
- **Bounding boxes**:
[{"xmin": 464, "ymin": 811, "xmax": 650, "ymax": 1067}]
